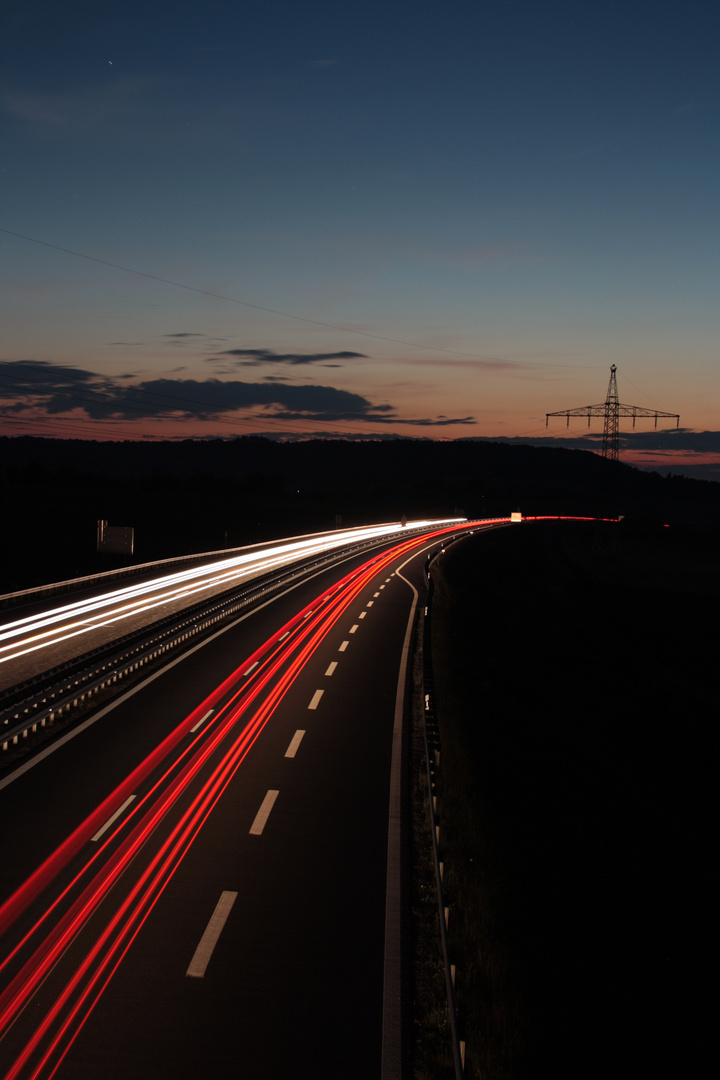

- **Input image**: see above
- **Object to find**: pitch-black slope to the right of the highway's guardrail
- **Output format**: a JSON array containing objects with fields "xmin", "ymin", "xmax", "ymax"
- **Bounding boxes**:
[{"xmin": 433, "ymin": 524, "xmax": 720, "ymax": 1080}]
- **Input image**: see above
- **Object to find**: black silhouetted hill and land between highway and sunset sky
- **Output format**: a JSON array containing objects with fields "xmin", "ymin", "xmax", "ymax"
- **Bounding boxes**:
[{"xmin": 0, "ymin": 436, "xmax": 720, "ymax": 592}]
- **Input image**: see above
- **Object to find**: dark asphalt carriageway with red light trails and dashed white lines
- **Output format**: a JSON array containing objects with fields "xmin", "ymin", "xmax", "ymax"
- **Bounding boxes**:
[{"xmin": 0, "ymin": 525, "xmax": 496, "ymax": 1080}]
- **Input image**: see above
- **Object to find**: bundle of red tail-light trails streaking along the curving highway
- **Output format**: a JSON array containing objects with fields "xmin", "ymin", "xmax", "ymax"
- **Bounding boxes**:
[{"xmin": 0, "ymin": 518, "xmax": 472, "ymax": 1080}]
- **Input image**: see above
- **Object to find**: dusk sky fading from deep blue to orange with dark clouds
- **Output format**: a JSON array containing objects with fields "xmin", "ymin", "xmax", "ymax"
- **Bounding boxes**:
[{"xmin": 0, "ymin": 0, "xmax": 720, "ymax": 480}]
